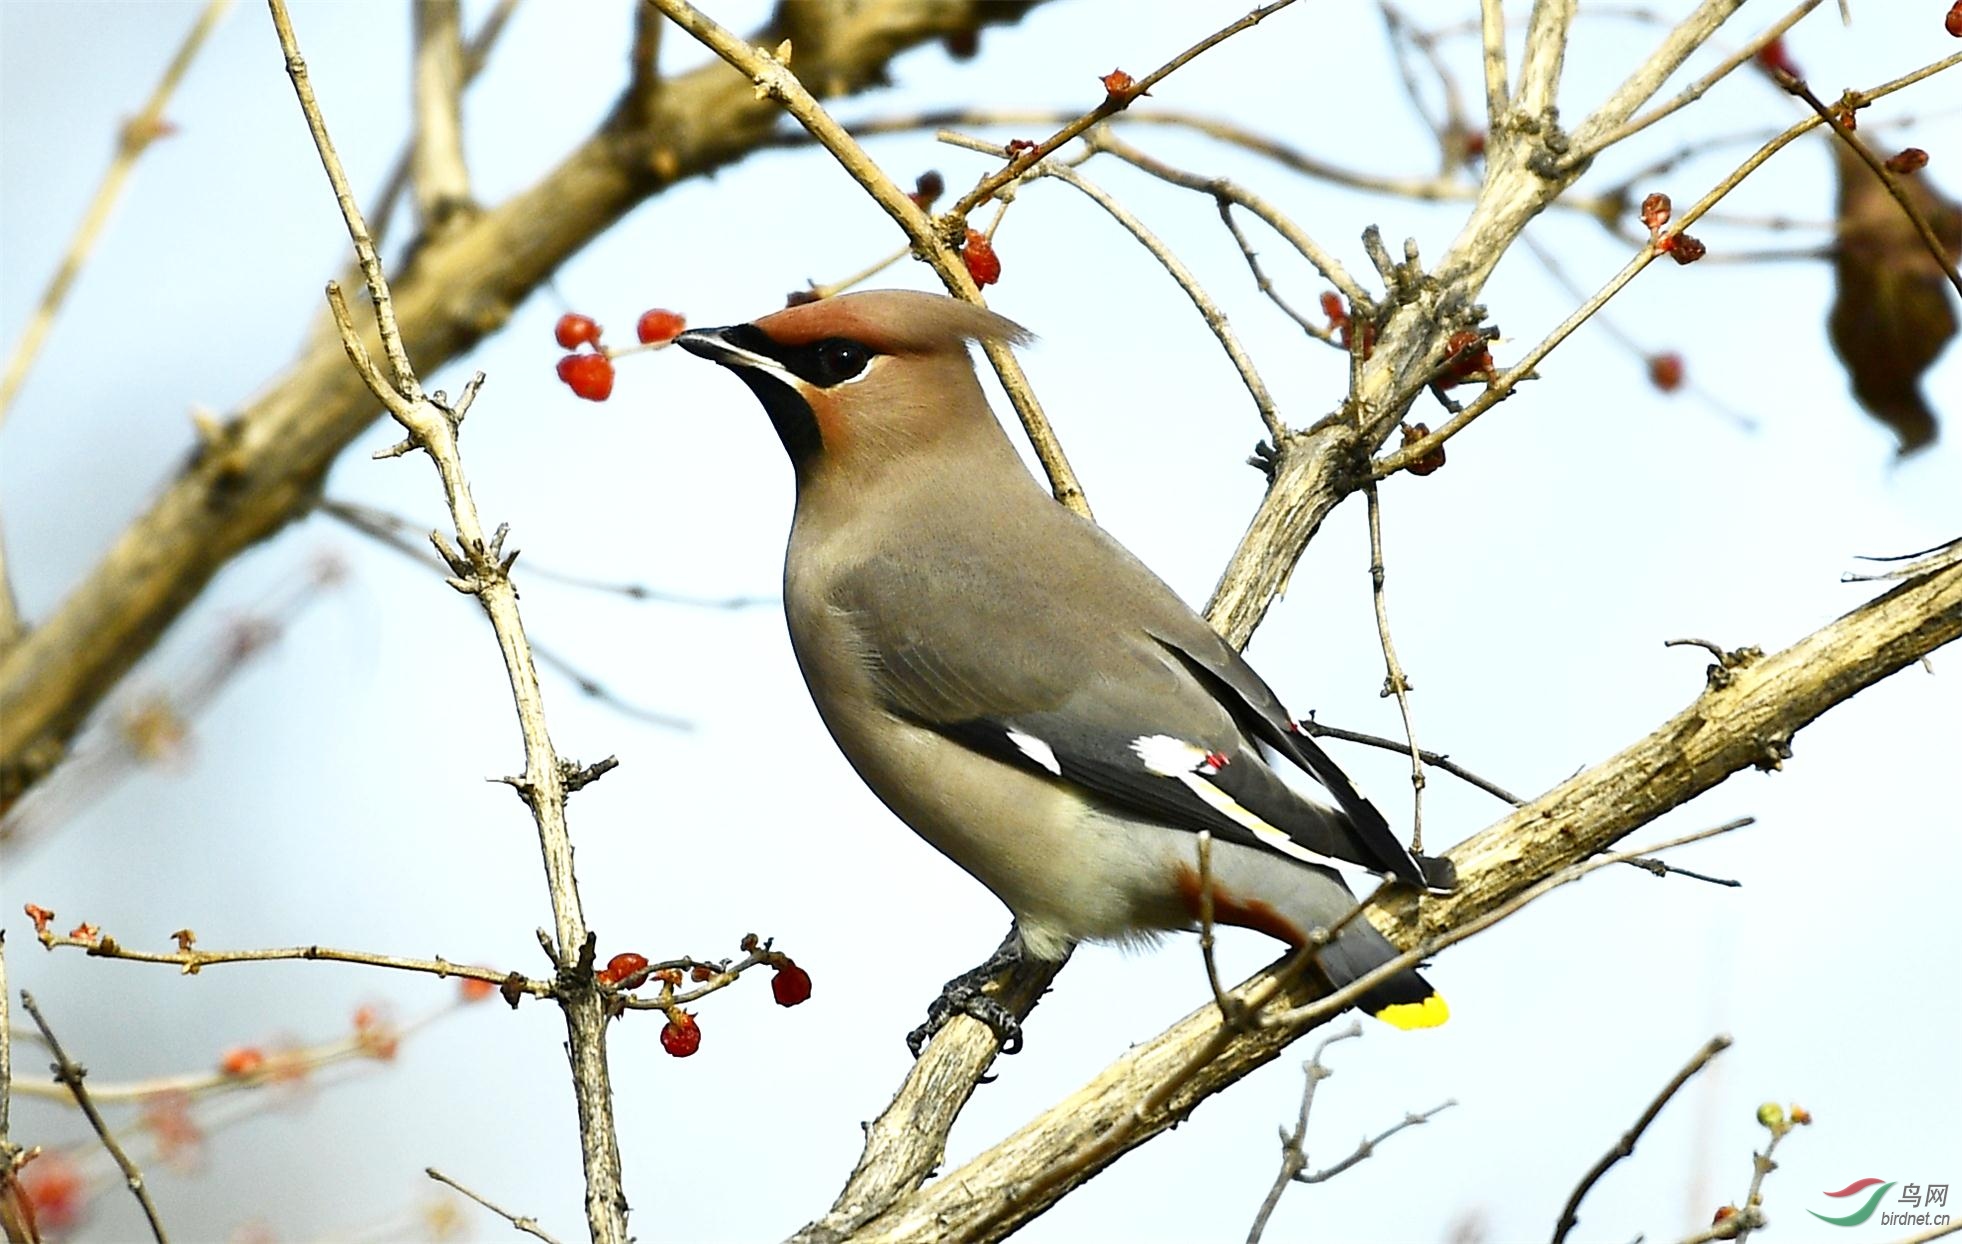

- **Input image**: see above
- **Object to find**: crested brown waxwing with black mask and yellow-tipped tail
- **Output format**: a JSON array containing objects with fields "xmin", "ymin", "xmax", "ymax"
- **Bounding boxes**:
[{"xmin": 679, "ymin": 290, "xmax": 1454, "ymax": 1048}]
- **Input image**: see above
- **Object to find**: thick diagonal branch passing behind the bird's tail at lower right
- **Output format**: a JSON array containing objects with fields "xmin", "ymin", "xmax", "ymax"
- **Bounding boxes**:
[{"xmin": 848, "ymin": 565, "xmax": 1962, "ymax": 1242}]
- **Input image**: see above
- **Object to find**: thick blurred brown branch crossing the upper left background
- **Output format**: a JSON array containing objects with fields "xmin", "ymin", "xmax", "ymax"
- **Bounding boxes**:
[{"xmin": 0, "ymin": 0, "xmax": 1038, "ymax": 806}]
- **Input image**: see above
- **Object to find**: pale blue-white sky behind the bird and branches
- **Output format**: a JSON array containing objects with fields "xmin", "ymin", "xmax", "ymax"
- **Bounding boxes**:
[{"xmin": 0, "ymin": 0, "xmax": 1962, "ymax": 1242}]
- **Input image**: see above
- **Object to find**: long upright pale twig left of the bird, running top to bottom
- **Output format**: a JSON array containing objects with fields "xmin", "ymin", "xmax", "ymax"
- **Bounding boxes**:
[{"xmin": 269, "ymin": 0, "xmax": 628, "ymax": 1244}]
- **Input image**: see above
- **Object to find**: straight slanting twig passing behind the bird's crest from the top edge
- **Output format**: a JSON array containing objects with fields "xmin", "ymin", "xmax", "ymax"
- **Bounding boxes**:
[{"xmin": 649, "ymin": 0, "xmax": 1098, "ymax": 516}]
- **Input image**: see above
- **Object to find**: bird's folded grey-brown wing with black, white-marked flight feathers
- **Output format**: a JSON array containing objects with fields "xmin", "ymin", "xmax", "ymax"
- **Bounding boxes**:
[{"xmin": 834, "ymin": 551, "xmax": 1409, "ymax": 875}]
